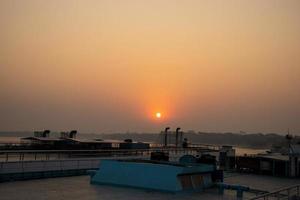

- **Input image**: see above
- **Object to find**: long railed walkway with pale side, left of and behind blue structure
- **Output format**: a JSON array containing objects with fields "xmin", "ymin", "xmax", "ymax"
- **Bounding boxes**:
[{"xmin": 0, "ymin": 148, "xmax": 211, "ymax": 182}]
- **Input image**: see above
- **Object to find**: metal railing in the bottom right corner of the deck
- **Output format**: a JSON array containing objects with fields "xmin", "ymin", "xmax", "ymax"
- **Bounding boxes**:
[{"xmin": 250, "ymin": 185, "xmax": 300, "ymax": 200}]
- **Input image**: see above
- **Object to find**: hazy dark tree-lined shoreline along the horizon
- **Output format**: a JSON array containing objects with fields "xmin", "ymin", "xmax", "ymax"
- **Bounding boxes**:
[{"xmin": 0, "ymin": 132, "xmax": 290, "ymax": 149}]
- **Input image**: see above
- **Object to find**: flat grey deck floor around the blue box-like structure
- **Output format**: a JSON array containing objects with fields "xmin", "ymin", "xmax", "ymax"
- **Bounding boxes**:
[{"xmin": 0, "ymin": 173, "xmax": 300, "ymax": 200}]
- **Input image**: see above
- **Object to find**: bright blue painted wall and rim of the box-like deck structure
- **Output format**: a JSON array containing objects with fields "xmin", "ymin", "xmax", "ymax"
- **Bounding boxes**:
[{"xmin": 91, "ymin": 160, "xmax": 214, "ymax": 192}]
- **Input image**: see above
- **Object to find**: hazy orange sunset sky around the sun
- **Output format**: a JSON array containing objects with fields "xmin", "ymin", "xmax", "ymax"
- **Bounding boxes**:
[{"xmin": 0, "ymin": 0, "xmax": 300, "ymax": 135}]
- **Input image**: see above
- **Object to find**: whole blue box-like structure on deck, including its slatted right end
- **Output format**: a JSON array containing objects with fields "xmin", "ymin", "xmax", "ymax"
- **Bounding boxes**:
[{"xmin": 91, "ymin": 160, "xmax": 221, "ymax": 192}]
